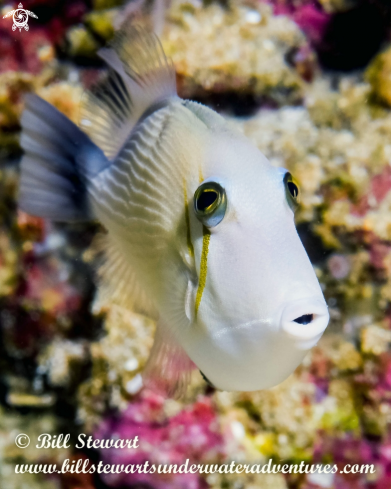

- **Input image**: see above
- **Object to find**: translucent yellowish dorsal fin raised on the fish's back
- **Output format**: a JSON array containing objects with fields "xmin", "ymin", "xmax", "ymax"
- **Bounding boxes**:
[{"xmin": 80, "ymin": 26, "xmax": 177, "ymax": 161}]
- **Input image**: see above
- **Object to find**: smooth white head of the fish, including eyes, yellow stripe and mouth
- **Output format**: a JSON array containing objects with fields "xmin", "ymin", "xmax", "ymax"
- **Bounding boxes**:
[{"xmin": 184, "ymin": 127, "xmax": 329, "ymax": 391}]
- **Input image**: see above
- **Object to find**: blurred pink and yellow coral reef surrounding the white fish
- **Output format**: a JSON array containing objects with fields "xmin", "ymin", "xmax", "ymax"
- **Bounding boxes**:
[{"xmin": 0, "ymin": 0, "xmax": 391, "ymax": 489}]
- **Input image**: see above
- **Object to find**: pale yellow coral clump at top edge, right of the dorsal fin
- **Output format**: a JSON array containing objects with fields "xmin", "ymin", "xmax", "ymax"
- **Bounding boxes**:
[{"xmin": 162, "ymin": 2, "xmax": 305, "ymax": 102}]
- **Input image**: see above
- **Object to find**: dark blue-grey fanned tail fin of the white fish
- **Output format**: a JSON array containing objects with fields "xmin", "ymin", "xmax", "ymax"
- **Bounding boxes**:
[{"xmin": 19, "ymin": 95, "xmax": 109, "ymax": 221}]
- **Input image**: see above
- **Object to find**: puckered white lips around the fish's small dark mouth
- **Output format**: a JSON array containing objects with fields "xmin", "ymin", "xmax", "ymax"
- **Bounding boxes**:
[{"xmin": 280, "ymin": 297, "xmax": 329, "ymax": 348}]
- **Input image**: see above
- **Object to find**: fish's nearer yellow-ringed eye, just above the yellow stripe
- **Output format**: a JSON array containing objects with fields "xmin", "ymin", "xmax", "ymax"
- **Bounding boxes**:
[{"xmin": 194, "ymin": 182, "xmax": 227, "ymax": 228}]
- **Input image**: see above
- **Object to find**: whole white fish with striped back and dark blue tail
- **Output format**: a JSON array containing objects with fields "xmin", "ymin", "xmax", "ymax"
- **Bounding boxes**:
[{"xmin": 19, "ymin": 27, "xmax": 329, "ymax": 395}]
